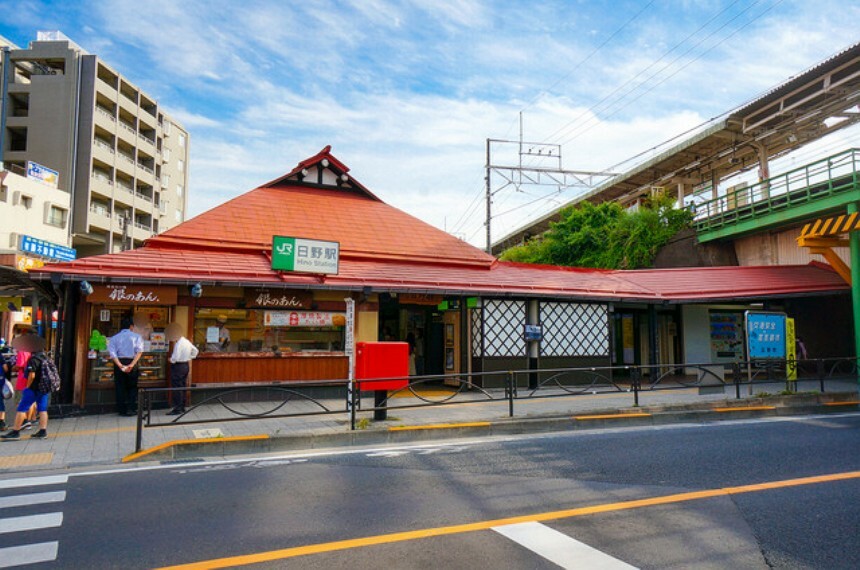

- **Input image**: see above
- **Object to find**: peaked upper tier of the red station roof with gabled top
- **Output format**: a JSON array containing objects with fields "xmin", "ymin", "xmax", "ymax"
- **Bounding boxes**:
[{"xmin": 146, "ymin": 147, "xmax": 495, "ymax": 267}]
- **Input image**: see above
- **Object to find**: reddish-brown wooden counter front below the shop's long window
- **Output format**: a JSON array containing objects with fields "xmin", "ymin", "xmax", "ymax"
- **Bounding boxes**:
[{"xmin": 191, "ymin": 352, "xmax": 349, "ymax": 384}]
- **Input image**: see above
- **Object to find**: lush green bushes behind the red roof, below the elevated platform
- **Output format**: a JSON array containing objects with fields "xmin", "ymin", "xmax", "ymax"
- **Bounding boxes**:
[{"xmin": 500, "ymin": 194, "xmax": 692, "ymax": 269}]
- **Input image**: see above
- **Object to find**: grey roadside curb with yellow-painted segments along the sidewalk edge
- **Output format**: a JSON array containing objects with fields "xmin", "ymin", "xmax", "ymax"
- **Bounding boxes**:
[{"xmin": 122, "ymin": 393, "xmax": 860, "ymax": 463}]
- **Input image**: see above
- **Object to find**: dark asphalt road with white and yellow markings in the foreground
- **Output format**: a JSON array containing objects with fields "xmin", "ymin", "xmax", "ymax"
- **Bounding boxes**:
[{"xmin": 0, "ymin": 414, "xmax": 860, "ymax": 569}]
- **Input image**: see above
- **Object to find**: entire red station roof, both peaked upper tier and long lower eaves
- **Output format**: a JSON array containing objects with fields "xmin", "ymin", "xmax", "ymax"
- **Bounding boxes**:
[{"xmin": 32, "ymin": 147, "xmax": 849, "ymax": 302}]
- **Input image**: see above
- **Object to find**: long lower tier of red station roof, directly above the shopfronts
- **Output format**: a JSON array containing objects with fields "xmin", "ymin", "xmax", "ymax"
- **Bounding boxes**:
[{"xmin": 31, "ymin": 247, "xmax": 849, "ymax": 302}]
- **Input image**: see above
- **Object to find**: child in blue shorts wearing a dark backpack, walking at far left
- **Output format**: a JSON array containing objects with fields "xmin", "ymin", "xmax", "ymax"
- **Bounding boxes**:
[{"xmin": 0, "ymin": 335, "xmax": 50, "ymax": 441}]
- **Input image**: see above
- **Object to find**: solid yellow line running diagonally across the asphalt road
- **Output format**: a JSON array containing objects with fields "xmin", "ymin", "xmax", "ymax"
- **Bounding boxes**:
[{"xmin": 155, "ymin": 471, "xmax": 860, "ymax": 570}]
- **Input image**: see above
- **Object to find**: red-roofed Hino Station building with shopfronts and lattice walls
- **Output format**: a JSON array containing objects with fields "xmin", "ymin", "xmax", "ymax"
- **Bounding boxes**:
[{"xmin": 33, "ymin": 147, "xmax": 853, "ymax": 407}]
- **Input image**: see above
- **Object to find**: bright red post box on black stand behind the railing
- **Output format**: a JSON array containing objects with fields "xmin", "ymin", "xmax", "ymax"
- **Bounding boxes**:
[{"xmin": 355, "ymin": 342, "xmax": 409, "ymax": 392}]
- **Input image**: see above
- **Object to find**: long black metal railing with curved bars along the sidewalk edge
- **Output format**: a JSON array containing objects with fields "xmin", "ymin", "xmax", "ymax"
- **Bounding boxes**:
[{"xmin": 135, "ymin": 357, "xmax": 858, "ymax": 451}]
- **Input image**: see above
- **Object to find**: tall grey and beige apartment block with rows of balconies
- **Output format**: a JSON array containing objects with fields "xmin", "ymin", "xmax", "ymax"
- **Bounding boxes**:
[{"xmin": 0, "ymin": 28, "xmax": 190, "ymax": 257}]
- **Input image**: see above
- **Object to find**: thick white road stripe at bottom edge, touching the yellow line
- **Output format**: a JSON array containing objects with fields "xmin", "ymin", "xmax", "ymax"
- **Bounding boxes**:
[{"xmin": 493, "ymin": 522, "xmax": 636, "ymax": 570}]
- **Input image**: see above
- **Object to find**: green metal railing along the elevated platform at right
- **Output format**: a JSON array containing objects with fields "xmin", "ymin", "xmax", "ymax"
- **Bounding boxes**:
[{"xmin": 694, "ymin": 148, "xmax": 860, "ymax": 241}]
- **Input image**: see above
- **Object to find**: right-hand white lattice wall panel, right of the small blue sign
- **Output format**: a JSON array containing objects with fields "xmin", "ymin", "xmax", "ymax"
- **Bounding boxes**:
[{"xmin": 540, "ymin": 302, "xmax": 609, "ymax": 356}]
